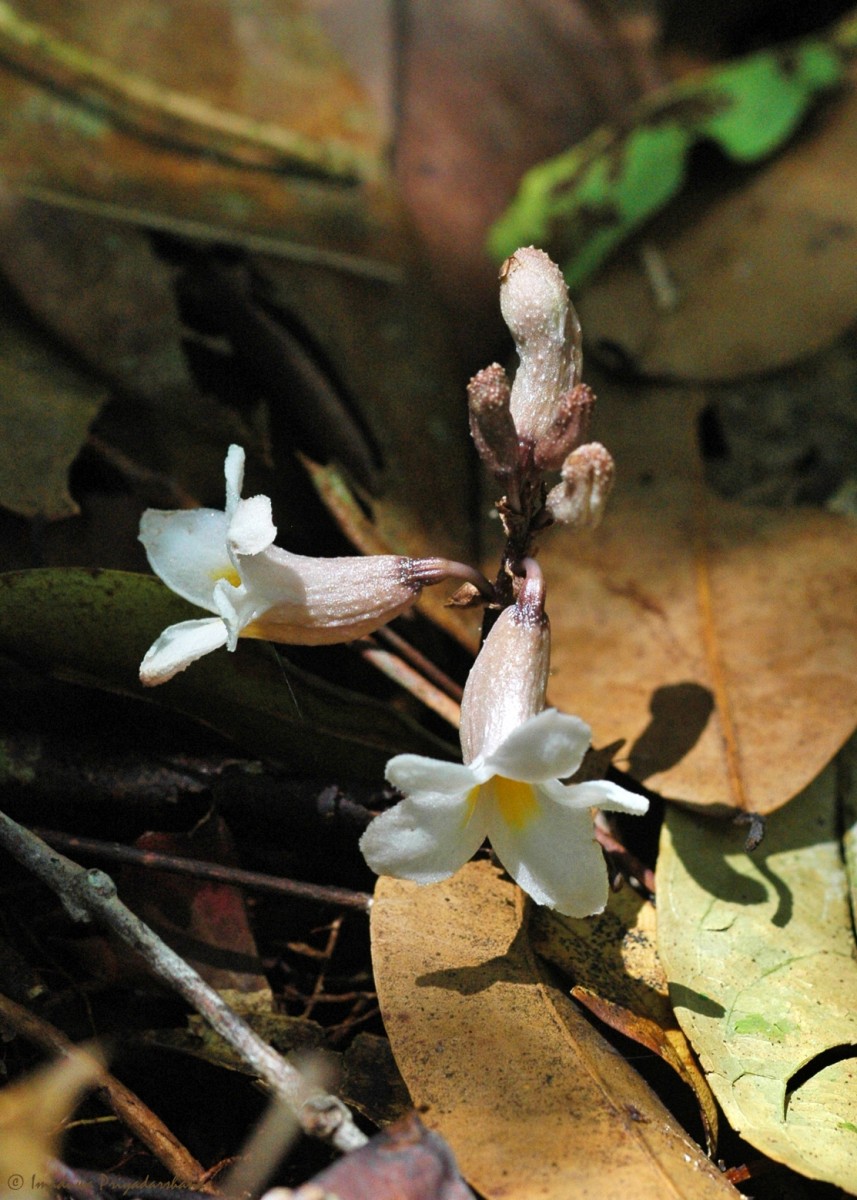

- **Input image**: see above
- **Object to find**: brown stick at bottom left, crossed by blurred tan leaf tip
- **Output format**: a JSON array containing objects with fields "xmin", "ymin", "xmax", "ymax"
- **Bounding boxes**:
[{"xmin": 0, "ymin": 995, "xmax": 205, "ymax": 1188}]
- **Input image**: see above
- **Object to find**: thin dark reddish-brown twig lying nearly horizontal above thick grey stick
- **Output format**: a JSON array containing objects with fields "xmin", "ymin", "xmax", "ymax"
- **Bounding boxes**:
[{"xmin": 32, "ymin": 829, "xmax": 372, "ymax": 912}]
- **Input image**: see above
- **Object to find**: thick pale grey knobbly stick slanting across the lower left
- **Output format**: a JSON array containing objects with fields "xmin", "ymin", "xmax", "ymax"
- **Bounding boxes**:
[{"xmin": 0, "ymin": 812, "xmax": 368, "ymax": 1151}]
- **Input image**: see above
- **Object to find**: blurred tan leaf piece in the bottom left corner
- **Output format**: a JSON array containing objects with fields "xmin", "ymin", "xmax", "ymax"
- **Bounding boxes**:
[{"xmin": 0, "ymin": 1050, "xmax": 102, "ymax": 1200}]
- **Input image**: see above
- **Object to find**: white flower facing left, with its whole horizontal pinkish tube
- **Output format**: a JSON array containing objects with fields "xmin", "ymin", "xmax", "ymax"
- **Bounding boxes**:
[{"xmin": 140, "ymin": 445, "xmax": 477, "ymax": 686}]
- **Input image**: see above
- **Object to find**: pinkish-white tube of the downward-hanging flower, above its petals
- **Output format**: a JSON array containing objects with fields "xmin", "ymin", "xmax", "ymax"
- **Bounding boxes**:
[{"xmin": 460, "ymin": 563, "xmax": 551, "ymax": 763}]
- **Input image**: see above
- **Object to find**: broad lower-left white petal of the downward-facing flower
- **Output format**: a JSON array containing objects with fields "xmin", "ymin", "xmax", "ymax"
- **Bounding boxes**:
[{"xmin": 360, "ymin": 792, "xmax": 485, "ymax": 883}]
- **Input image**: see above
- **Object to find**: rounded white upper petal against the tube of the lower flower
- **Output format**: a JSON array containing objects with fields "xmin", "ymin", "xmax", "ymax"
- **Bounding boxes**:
[{"xmin": 485, "ymin": 708, "xmax": 592, "ymax": 784}]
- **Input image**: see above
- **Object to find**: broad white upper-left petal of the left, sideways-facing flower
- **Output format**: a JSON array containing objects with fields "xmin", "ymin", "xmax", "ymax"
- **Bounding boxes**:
[{"xmin": 139, "ymin": 509, "xmax": 234, "ymax": 612}]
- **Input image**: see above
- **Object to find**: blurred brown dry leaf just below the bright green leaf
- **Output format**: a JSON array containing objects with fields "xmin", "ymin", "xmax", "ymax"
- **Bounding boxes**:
[{"xmin": 579, "ymin": 67, "xmax": 857, "ymax": 380}]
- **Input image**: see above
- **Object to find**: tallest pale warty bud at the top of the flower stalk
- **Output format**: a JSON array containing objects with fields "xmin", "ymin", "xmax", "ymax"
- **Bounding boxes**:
[{"xmin": 499, "ymin": 246, "xmax": 581, "ymax": 443}]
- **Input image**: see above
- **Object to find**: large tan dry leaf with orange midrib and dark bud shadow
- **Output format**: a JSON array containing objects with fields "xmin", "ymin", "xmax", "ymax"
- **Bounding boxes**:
[{"xmin": 540, "ymin": 380, "xmax": 857, "ymax": 812}]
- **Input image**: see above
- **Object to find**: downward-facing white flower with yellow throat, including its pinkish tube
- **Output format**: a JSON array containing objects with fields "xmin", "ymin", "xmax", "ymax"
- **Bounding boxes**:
[{"xmin": 360, "ymin": 566, "xmax": 648, "ymax": 917}]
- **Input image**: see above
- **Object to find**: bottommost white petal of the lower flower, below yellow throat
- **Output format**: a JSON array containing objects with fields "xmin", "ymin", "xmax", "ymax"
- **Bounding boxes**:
[{"xmin": 489, "ymin": 787, "xmax": 607, "ymax": 917}]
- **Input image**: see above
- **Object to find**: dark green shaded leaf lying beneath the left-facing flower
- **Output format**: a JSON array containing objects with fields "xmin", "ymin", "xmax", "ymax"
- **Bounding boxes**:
[{"xmin": 0, "ymin": 569, "xmax": 451, "ymax": 780}]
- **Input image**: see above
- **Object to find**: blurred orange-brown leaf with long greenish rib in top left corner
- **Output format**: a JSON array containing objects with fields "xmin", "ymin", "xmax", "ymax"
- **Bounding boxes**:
[{"xmin": 0, "ymin": 0, "xmax": 402, "ymax": 267}]
